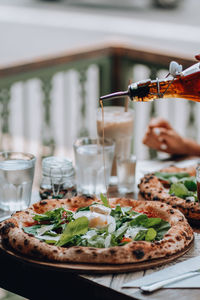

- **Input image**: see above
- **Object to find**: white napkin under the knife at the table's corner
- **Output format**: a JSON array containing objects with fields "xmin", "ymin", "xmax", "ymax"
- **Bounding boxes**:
[{"xmin": 122, "ymin": 256, "xmax": 200, "ymax": 288}]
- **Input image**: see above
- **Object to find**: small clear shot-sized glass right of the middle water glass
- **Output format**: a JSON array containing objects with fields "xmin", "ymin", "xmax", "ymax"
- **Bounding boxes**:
[{"xmin": 117, "ymin": 155, "xmax": 136, "ymax": 194}]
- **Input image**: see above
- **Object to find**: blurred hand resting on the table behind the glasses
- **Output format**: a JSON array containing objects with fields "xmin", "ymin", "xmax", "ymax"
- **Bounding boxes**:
[{"xmin": 143, "ymin": 118, "xmax": 189, "ymax": 155}]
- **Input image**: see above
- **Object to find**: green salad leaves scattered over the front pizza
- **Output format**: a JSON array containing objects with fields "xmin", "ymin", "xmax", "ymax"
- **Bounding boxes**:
[{"xmin": 24, "ymin": 204, "xmax": 170, "ymax": 248}]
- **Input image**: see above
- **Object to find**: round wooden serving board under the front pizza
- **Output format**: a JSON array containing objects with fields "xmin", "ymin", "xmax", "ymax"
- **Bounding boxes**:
[{"xmin": 0, "ymin": 241, "xmax": 194, "ymax": 274}]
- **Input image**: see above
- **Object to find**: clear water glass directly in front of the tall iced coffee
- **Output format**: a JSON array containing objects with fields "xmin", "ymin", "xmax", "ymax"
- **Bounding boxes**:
[{"xmin": 74, "ymin": 137, "xmax": 115, "ymax": 195}]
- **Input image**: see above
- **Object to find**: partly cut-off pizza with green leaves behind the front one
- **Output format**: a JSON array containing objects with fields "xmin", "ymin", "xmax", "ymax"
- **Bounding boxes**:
[{"xmin": 138, "ymin": 166, "xmax": 200, "ymax": 225}]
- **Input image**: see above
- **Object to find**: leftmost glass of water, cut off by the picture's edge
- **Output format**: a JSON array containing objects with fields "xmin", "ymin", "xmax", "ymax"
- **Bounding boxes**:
[{"xmin": 0, "ymin": 152, "xmax": 36, "ymax": 212}]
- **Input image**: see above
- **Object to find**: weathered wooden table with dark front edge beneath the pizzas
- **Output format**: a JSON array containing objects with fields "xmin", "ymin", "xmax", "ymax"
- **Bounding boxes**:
[{"xmin": 0, "ymin": 160, "xmax": 200, "ymax": 300}]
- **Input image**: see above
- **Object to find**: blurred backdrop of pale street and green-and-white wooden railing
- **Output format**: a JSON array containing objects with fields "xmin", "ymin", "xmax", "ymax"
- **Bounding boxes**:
[{"xmin": 0, "ymin": 0, "xmax": 200, "ymax": 299}]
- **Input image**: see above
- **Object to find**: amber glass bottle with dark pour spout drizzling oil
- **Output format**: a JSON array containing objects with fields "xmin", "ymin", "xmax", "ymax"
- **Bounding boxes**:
[{"xmin": 100, "ymin": 62, "xmax": 200, "ymax": 102}]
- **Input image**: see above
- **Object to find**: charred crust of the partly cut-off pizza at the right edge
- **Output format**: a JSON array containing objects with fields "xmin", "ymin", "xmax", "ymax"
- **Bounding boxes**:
[{"xmin": 138, "ymin": 166, "xmax": 200, "ymax": 224}]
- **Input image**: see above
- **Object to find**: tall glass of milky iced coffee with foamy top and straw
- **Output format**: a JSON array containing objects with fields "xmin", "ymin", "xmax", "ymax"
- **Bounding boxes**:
[{"xmin": 97, "ymin": 106, "xmax": 134, "ymax": 176}]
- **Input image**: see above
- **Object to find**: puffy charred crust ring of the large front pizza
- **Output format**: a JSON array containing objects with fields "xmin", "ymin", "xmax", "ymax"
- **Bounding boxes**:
[{"xmin": 0, "ymin": 196, "xmax": 194, "ymax": 264}]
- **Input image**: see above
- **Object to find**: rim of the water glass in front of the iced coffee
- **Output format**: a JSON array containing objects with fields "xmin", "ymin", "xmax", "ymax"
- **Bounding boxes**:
[{"xmin": 73, "ymin": 137, "xmax": 115, "ymax": 149}]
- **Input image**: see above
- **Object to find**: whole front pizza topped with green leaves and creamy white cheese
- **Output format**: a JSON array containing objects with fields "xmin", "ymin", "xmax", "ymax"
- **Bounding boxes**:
[{"xmin": 0, "ymin": 196, "xmax": 193, "ymax": 264}]
